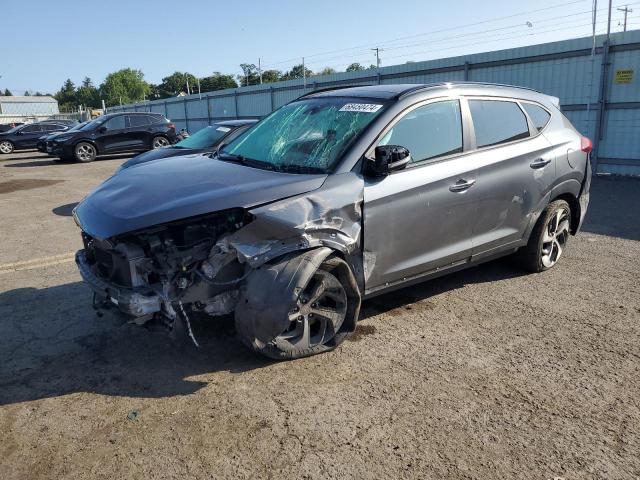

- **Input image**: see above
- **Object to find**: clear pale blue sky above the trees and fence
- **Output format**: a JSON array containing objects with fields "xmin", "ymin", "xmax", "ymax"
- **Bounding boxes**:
[{"xmin": 0, "ymin": 0, "xmax": 640, "ymax": 95}]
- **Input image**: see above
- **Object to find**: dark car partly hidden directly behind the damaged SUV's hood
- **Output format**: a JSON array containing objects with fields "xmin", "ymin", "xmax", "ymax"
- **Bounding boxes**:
[{"xmin": 118, "ymin": 120, "xmax": 258, "ymax": 171}]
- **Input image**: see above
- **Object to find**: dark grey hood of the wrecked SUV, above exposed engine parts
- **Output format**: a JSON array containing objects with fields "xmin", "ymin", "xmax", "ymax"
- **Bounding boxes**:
[{"xmin": 74, "ymin": 155, "xmax": 326, "ymax": 239}]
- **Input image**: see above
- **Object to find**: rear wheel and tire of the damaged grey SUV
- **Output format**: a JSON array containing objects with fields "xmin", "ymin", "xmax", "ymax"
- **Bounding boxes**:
[{"xmin": 514, "ymin": 200, "xmax": 571, "ymax": 273}]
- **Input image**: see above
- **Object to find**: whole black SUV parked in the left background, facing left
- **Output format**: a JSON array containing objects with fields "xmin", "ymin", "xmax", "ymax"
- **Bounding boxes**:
[{"xmin": 47, "ymin": 112, "xmax": 176, "ymax": 162}]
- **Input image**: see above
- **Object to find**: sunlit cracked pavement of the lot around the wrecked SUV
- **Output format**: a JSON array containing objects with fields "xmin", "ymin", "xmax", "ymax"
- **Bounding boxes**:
[{"xmin": 0, "ymin": 152, "xmax": 640, "ymax": 480}]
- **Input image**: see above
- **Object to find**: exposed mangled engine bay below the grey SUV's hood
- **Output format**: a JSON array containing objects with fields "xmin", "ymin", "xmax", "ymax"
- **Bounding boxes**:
[{"xmin": 77, "ymin": 209, "xmax": 251, "ymax": 344}]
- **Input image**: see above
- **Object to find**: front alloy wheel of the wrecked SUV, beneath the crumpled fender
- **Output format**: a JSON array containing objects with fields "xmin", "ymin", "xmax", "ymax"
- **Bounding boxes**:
[{"xmin": 274, "ymin": 270, "xmax": 347, "ymax": 350}]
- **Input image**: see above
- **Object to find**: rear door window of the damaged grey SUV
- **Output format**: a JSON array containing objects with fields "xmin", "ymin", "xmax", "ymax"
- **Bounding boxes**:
[{"xmin": 469, "ymin": 100, "xmax": 529, "ymax": 148}]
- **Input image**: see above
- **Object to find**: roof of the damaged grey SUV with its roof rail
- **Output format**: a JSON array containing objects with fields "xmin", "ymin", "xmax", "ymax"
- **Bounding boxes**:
[{"xmin": 303, "ymin": 82, "xmax": 551, "ymax": 104}]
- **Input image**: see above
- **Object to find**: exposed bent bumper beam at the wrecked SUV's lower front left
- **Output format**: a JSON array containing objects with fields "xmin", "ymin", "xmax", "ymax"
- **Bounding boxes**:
[{"xmin": 76, "ymin": 250, "xmax": 162, "ymax": 317}]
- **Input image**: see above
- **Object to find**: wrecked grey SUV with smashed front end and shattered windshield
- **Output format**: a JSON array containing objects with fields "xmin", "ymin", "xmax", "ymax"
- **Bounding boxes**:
[{"xmin": 74, "ymin": 83, "xmax": 591, "ymax": 359}]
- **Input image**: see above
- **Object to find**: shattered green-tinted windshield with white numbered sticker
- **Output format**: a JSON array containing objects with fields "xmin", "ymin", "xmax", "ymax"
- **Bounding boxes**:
[{"xmin": 220, "ymin": 97, "xmax": 384, "ymax": 173}]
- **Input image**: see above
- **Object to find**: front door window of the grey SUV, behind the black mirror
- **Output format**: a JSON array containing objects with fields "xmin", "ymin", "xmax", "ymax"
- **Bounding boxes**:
[{"xmin": 378, "ymin": 100, "xmax": 462, "ymax": 163}]
